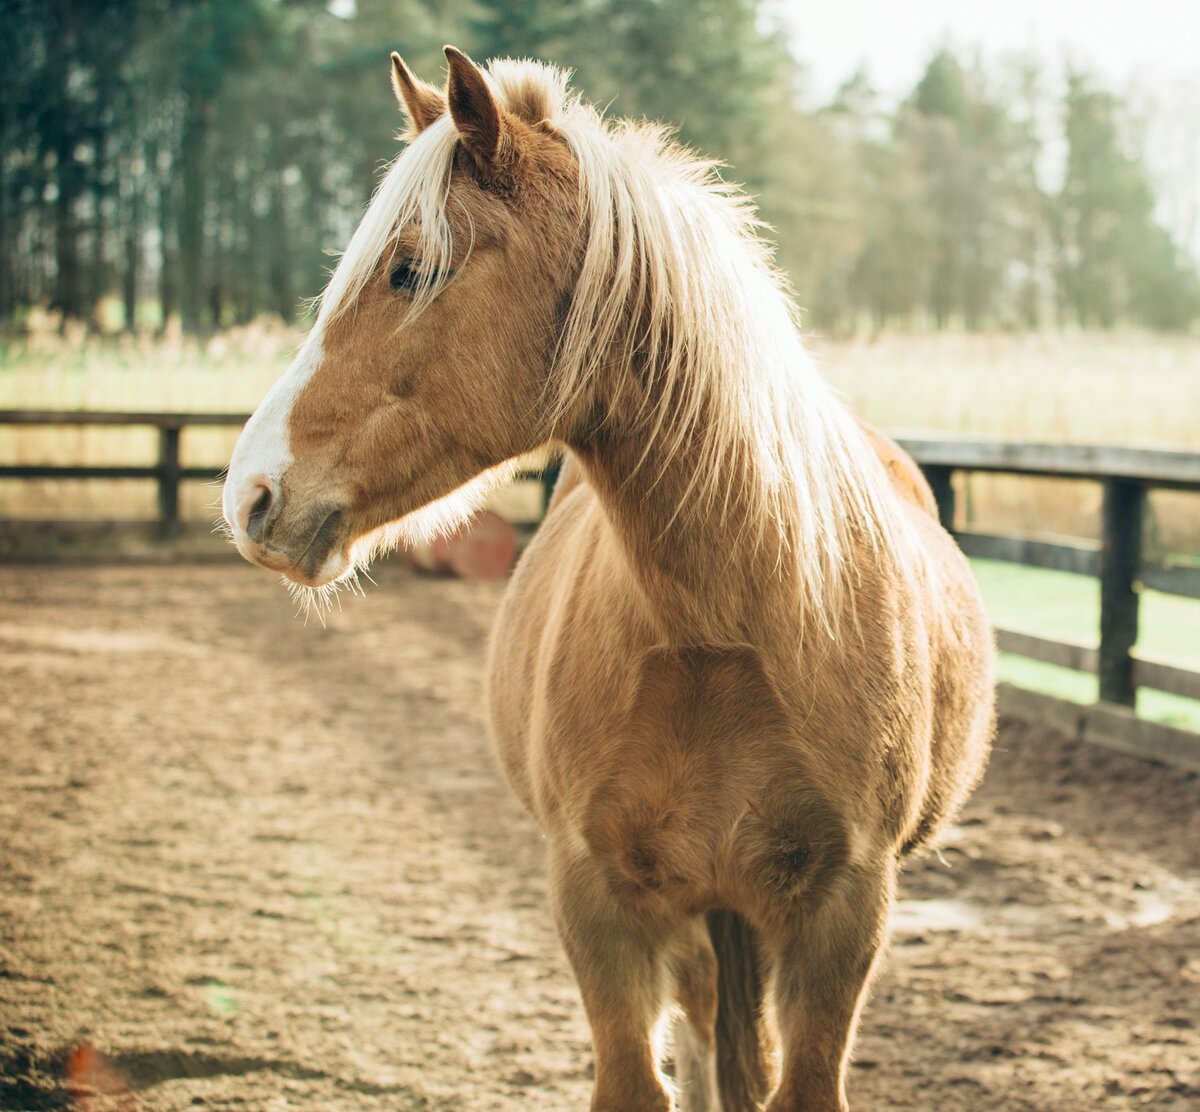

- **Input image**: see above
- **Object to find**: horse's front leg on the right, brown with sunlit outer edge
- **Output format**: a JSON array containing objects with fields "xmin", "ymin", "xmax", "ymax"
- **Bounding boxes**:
[{"xmin": 767, "ymin": 861, "xmax": 895, "ymax": 1112}]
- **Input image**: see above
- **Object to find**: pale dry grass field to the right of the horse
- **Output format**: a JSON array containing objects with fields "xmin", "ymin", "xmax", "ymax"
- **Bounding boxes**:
[{"xmin": 816, "ymin": 333, "xmax": 1200, "ymax": 553}]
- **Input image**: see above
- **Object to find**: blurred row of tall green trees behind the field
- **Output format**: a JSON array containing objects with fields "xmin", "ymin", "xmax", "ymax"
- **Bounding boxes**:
[{"xmin": 0, "ymin": 0, "xmax": 1200, "ymax": 332}]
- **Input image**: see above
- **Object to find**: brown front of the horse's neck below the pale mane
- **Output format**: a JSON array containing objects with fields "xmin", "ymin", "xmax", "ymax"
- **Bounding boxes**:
[{"xmin": 574, "ymin": 381, "xmax": 800, "ymax": 644}]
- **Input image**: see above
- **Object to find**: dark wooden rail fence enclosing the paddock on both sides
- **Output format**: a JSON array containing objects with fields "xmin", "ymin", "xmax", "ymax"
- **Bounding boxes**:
[{"xmin": 0, "ymin": 410, "xmax": 1200, "ymax": 771}]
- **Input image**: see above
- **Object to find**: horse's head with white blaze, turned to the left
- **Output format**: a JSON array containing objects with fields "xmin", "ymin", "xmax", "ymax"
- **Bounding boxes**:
[{"xmin": 223, "ymin": 47, "xmax": 581, "ymax": 587}]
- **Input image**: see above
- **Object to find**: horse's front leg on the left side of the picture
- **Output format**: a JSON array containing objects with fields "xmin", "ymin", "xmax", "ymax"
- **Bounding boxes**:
[{"xmin": 551, "ymin": 847, "xmax": 671, "ymax": 1112}]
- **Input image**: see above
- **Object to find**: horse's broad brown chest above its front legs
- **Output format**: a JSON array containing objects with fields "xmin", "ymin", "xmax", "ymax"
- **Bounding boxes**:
[{"xmin": 573, "ymin": 650, "xmax": 845, "ymax": 910}]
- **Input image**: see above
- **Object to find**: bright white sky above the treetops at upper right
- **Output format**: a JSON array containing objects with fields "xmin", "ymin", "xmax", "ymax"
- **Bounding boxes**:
[{"xmin": 768, "ymin": 0, "xmax": 1200, "ymax": 100}]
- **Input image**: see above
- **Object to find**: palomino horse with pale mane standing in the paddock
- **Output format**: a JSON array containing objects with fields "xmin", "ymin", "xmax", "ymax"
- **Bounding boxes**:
[{"xmin": 224, "ymin": 48, "xmax": 992, "ymax": 1112}]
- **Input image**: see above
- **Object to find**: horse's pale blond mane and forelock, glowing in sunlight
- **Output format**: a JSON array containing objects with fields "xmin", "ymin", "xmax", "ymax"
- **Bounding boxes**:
[{"xmin": 318, "ymin": 60, "xmax": 913, "ymax": 631}]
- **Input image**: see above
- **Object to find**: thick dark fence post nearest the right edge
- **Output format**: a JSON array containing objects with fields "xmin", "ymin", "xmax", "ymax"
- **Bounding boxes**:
[{"xmin": 1098, "ymin": 479, "xmax": 1146, "ymax": 707}]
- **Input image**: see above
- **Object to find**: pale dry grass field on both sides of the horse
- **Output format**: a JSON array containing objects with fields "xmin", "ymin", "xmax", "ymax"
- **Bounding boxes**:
[{"xmin": 0, "ymin": 320, "xmax": 1200, "ymax": 552}]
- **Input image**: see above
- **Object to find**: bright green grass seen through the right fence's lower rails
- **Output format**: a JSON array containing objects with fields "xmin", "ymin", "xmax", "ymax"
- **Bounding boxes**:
[{"xmin": 971, "ymin": 560, "xmax": 1200, "ymax": 729}]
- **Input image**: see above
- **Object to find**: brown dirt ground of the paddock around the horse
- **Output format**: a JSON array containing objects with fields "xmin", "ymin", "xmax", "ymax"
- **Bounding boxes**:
[{"xmin": 0, "ymin": 564, "xmax": 1200, "ymax": 1112}]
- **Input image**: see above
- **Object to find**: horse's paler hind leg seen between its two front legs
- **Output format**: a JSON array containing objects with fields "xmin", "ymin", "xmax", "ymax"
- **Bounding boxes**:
[{"xmin": 671, "ymin": 916, "xmax": 721, "ymax": 1112}]
